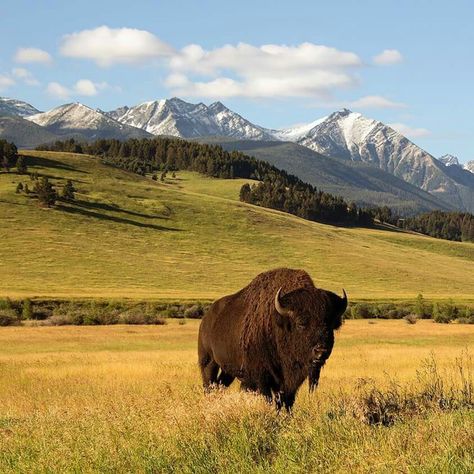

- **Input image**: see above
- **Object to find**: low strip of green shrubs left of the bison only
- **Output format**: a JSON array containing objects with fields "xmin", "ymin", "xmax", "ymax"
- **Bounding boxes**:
[{"xmin": 0, "ymin": 299, "xmax": 207, "ymax": 326}]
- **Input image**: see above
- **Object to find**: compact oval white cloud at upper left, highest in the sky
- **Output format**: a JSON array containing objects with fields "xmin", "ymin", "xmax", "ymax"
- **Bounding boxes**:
[{"xmin": 60, "ymin": 26, "xmax": 173, "ymax": 66}]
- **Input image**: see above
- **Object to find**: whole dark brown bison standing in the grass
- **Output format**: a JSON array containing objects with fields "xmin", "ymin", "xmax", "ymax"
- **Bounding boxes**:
[{"xmin": 198, "ymin": 268, "xmax": 347, "ymax": 409}]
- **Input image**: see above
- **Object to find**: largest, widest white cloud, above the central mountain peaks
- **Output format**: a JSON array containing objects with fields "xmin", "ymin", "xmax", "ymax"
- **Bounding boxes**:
[{"xmin": 166, "ymin": 43, "xmax": 362, "ymax": 98}]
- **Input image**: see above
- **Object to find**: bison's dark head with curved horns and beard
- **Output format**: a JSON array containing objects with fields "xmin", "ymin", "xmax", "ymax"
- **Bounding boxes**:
[{"xmin": 275, "ymin": 288, "xmax": 347, "ymax": 391}]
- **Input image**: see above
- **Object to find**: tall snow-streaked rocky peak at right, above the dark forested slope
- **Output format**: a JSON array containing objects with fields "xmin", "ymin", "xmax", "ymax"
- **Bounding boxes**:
[{"xmin": 280, "ymin": 109, "xmax": 474, "ymax": 212}]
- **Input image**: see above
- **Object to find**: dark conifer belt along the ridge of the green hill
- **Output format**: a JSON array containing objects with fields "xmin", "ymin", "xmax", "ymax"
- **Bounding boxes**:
[{"xmin": 37, "ymin": 138, "xmax": 374, "ymax": 226}]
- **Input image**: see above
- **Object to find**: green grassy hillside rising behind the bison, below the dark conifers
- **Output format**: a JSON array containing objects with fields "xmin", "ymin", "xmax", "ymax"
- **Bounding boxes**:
[{"xmin": 0, "ymin": 152, "xmax": 474, "ymax": 300}]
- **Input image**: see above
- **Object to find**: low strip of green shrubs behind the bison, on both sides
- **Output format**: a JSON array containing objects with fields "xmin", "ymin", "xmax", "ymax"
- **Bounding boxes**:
[{"xmin": 0, "ymin": 295, "xmax": 474, "ymax": 326}]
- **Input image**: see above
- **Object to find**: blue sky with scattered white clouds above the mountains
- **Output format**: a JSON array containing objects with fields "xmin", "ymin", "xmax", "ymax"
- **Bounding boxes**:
[{"xmin": 0, "ymin": 0, "xmax": 474, "ymax": 162}]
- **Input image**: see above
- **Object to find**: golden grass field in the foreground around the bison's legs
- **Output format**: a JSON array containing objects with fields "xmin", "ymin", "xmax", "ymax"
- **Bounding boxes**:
[{"xmin": 0, "ymin": 320, "xmax": 474, "ymax": 473}]
